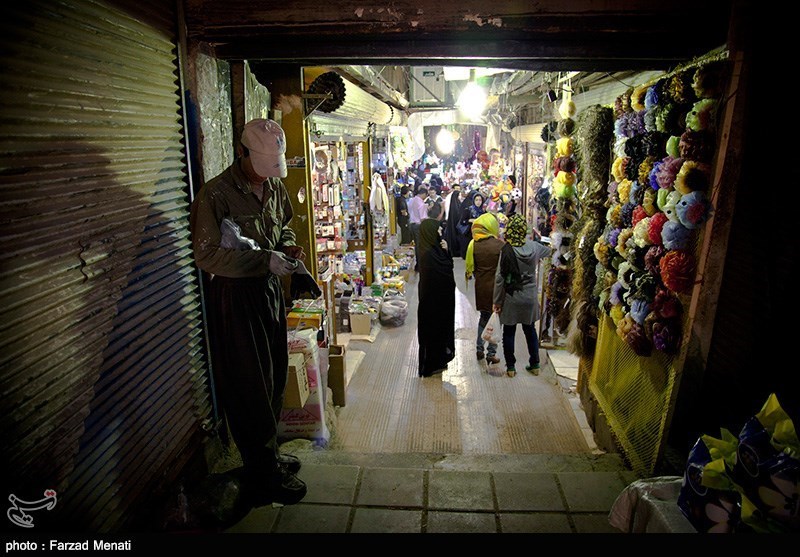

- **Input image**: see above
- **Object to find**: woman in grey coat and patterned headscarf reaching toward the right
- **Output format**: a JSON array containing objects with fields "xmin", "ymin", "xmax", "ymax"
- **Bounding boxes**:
[{"xmin": 493, "ymin": 215, "xmax": 550, "ymax": 377}]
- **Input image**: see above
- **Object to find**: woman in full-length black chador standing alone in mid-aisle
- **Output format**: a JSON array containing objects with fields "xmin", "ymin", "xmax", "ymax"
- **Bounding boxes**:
[{"xmin": 417, "ymin": 219, "xmax": 456, "ymax": 377}]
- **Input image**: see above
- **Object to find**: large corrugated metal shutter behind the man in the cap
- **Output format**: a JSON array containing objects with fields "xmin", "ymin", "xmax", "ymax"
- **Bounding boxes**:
[{"xmin": 0, "ymin": 0, "xmax": 210, "ymax": 531}]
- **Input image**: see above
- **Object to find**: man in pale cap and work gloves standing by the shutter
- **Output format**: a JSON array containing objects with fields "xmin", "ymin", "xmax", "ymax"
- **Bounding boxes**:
[{"xmin": 190, "ymin": 119, "xmax": 306, "ymax": 505}]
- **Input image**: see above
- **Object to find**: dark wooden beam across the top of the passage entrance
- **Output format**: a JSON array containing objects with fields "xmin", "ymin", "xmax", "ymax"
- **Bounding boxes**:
[{"xmin": 186, "ymin": 0, "xmax": 731, "ymax": 71}]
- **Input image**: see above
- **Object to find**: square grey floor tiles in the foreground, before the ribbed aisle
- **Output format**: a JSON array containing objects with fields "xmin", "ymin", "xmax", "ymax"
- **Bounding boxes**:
[{"xmin": 228, "ymin": 458, "xmax": 626, "ymax": 534}]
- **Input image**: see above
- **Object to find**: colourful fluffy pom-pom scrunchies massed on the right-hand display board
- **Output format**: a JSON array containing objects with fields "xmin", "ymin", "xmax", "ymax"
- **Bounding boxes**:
[{"xmin": 594, "ymin": 62, "xmax": 726, "ymax": 356}]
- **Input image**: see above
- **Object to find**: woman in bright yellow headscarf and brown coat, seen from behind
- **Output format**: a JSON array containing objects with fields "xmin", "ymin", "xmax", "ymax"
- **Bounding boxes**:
[{"xmin": 465, "ymin": 213, "xmax": 503, "ymax": 364}]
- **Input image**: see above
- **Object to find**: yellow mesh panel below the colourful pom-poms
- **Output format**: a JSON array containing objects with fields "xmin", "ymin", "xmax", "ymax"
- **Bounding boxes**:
[{"xmin": 588, "ymin": 315, "xmax": 675, "ymax": 476}]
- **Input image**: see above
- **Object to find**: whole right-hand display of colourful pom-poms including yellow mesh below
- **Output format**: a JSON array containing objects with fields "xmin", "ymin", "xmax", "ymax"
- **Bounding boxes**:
[{"xmin": 588, "ymin": 54, "xmax": 727, "ymax": 474}]
